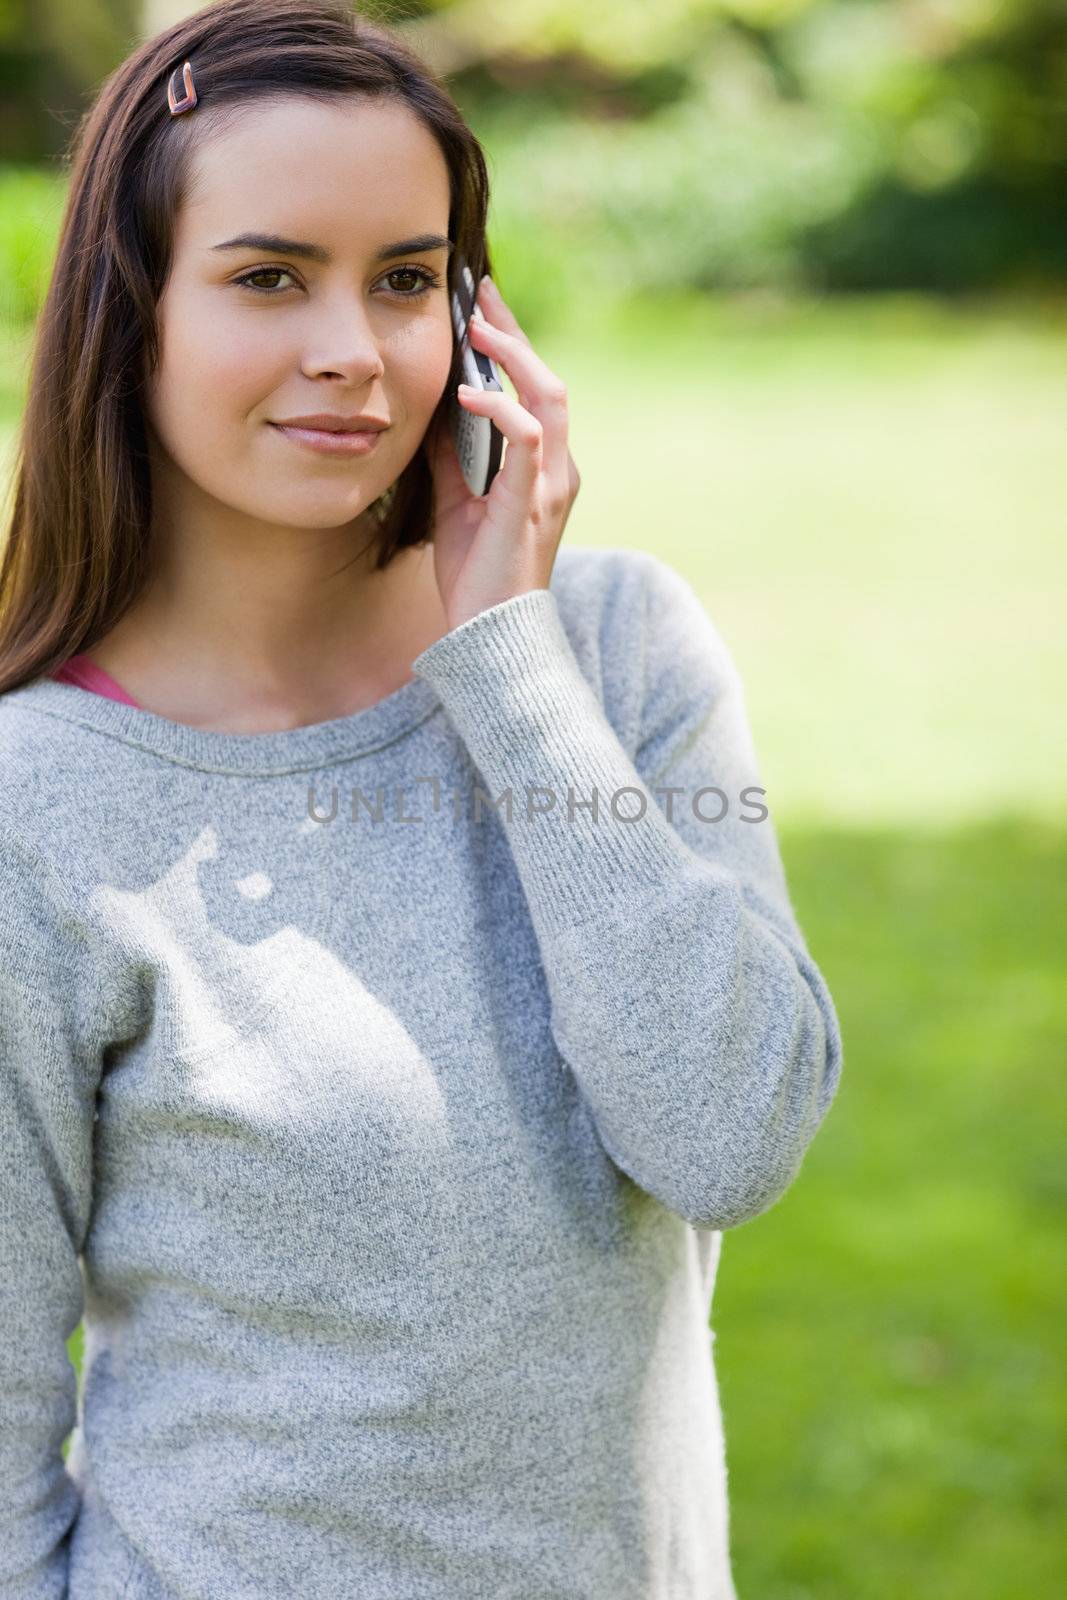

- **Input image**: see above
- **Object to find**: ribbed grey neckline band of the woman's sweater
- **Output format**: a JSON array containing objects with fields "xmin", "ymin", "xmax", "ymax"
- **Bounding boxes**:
[{"xmin": 0, "ymin": 677, "xmax": 442, "ymax": 778}]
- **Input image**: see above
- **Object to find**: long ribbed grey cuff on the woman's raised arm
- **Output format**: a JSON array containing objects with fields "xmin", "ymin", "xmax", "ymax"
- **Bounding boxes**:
[{"xmin": 413, "ymin": 589, "xmax": 693, "ymax": 931}]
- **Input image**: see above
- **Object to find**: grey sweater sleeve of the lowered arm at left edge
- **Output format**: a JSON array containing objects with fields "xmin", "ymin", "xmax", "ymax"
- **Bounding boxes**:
[{"xmin": 0, "ymin": 829, "xmax": 107, "ymax": 1600}]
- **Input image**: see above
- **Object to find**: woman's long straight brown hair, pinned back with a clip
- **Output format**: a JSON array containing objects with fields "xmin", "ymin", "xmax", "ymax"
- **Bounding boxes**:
[{"xmin": 0, "ymin": 0, "xmax": 491, "ymax": 694}]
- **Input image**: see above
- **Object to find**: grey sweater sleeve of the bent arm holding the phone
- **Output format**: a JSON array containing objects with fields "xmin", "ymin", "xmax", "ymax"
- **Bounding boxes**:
[{"xmin": 414, "ymin": 552, "xmax": 843, "ymax": 1229}]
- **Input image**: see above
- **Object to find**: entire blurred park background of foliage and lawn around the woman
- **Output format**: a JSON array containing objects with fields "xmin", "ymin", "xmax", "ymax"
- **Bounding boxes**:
[{"xmin": 0, "ymin": 0, "xmax": 1067, "ymax": 1600}]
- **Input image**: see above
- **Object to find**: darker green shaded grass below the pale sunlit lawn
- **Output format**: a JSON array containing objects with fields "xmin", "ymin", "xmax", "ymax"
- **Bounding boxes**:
[{"xmin": 723, "ymin": 822, "xmax": 1067, "ymax": 1600}]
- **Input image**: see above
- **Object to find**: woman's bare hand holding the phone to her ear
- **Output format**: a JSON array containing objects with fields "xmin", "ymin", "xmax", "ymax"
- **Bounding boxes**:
[{"xmin": 426, "ymin": 277, "xmax": 581, "ymax": 629}]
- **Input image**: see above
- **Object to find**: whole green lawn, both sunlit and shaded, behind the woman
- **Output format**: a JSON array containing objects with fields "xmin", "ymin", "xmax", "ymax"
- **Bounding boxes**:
[{"xmin": 0, "ymin": 294, "xmax": 1067, "ymax": 1600}]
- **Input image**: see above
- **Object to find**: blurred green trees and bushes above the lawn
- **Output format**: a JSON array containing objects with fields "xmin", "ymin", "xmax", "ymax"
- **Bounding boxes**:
[{"xmin": 0, "ymin": 0, "xmax": 1067, "ymax": 323}]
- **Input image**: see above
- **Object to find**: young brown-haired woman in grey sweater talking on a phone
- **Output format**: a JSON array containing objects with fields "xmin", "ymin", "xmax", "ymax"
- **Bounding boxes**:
[{"xmin": 0, "ymin": 0, "xmax": 841, "ymax": 1600}]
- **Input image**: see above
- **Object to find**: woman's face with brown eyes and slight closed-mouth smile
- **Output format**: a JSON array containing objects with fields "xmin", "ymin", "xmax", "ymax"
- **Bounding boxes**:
[{"xmin": 146, "ymin": 96, "xmax": 453, "ymax": 528}]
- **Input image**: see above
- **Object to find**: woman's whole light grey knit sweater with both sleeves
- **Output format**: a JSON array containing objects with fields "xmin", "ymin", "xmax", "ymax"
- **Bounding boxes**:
[{"xmin": 0, "ymin": 546, "xmax": 841, "ymax": 1600}]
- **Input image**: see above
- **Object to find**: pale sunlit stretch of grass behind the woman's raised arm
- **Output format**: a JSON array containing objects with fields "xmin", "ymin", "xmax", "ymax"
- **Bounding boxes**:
[{"xmin": 539, "ymin": 298, "xmax": 1067, "ymax": 827}]
